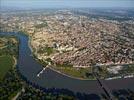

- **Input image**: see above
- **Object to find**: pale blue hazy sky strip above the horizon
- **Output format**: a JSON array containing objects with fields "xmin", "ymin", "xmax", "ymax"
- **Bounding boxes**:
[{"xmin": 0, "ymin": 0, "xmax": 134, "ymax": 8}]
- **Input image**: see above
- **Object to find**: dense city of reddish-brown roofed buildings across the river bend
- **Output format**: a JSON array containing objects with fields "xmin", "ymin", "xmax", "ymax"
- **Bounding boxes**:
[{"xmin": 1, "ymin": 10, "xmax": 134, "ymax": 67}]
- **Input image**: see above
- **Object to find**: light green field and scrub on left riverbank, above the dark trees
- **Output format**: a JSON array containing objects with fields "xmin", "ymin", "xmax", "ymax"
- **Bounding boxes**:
[{"xmin": 0, "ymin": 36, "xmax": 18, "ymax": 80}]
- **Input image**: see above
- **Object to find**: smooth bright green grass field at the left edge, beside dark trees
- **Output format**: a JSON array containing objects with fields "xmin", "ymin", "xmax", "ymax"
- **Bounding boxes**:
[{"xmin": 0, "ymin": 55, "xmax": 14, "ymax": 80}]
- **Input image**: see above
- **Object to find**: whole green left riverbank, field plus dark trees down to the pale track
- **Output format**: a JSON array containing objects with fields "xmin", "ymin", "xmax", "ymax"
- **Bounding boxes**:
[{"xmin": 0, "ymin": 36, "xmax": 22, "ymax": 100}]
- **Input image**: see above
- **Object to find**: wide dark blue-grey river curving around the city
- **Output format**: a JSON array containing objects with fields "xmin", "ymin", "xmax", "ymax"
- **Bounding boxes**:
[{"xmin": 0, "ymin": 32, "xmax": 134, "ymax": 94}]
